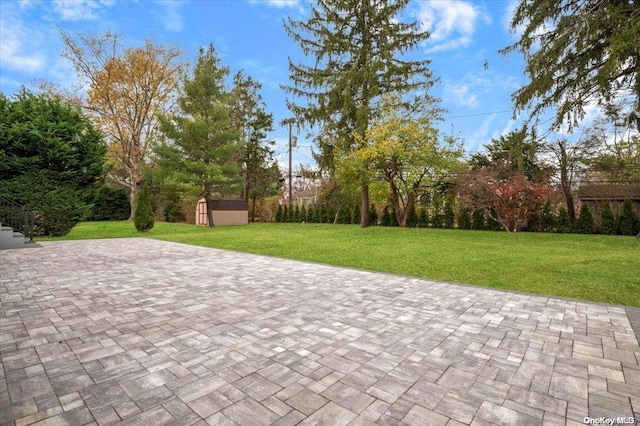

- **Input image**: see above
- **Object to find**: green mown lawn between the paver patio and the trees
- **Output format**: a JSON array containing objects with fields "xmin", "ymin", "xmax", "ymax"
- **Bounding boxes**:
[{"xmin": 37, "ymin": 221, "xmax": 640, "ymax": 306}]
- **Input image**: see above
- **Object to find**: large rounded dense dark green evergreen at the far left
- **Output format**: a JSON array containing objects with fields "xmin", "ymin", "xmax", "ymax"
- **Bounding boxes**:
[{"xmin": 0, "ymin": 88, "xmax": 106, "ymax": 235}]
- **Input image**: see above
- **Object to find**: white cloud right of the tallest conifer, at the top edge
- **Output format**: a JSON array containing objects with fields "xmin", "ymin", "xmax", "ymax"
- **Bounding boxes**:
[{"xmin": 417, "ymin": 0, "xmax": 491, "ymax": 52}]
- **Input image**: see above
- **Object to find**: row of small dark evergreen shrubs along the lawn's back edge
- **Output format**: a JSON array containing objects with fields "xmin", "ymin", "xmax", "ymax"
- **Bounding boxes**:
[{"xmin": 275, "ymin": 200, "xmax": 640, "ymax": 235}]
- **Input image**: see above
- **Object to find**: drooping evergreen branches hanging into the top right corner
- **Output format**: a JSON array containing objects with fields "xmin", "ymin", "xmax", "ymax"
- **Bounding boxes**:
[{"xmin": 502, "ymin": 0, "xmax": 640, "ymax": 130}]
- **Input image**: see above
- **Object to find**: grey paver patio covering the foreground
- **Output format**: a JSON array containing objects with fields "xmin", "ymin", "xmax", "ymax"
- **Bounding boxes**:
[{"xmin": 0, "ymin": 238, "xmax": 640, "ymax": 425}]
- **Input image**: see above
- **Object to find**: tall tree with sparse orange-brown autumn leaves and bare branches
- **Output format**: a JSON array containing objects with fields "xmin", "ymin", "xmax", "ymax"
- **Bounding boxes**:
[{"xmin": 54, "ymin": 31, "xmax": 183, "ymax": 219}]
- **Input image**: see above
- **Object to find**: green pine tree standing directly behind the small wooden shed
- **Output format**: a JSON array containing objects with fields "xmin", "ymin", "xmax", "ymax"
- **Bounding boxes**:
[{"xmin": 156, "ymin": 46, "xmax": 242, "ymax": 226}]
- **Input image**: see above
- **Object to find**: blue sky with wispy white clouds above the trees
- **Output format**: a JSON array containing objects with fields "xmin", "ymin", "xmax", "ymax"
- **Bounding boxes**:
[{"xmin": 0, "ymin": 0, "xmax": 527, "ymax": 170}]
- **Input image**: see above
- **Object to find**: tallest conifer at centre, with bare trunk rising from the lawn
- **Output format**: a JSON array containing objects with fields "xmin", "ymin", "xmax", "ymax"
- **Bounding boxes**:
[{"xmin": 284, "ymin": 0, "xmax": 435, "ymax": 226}]
